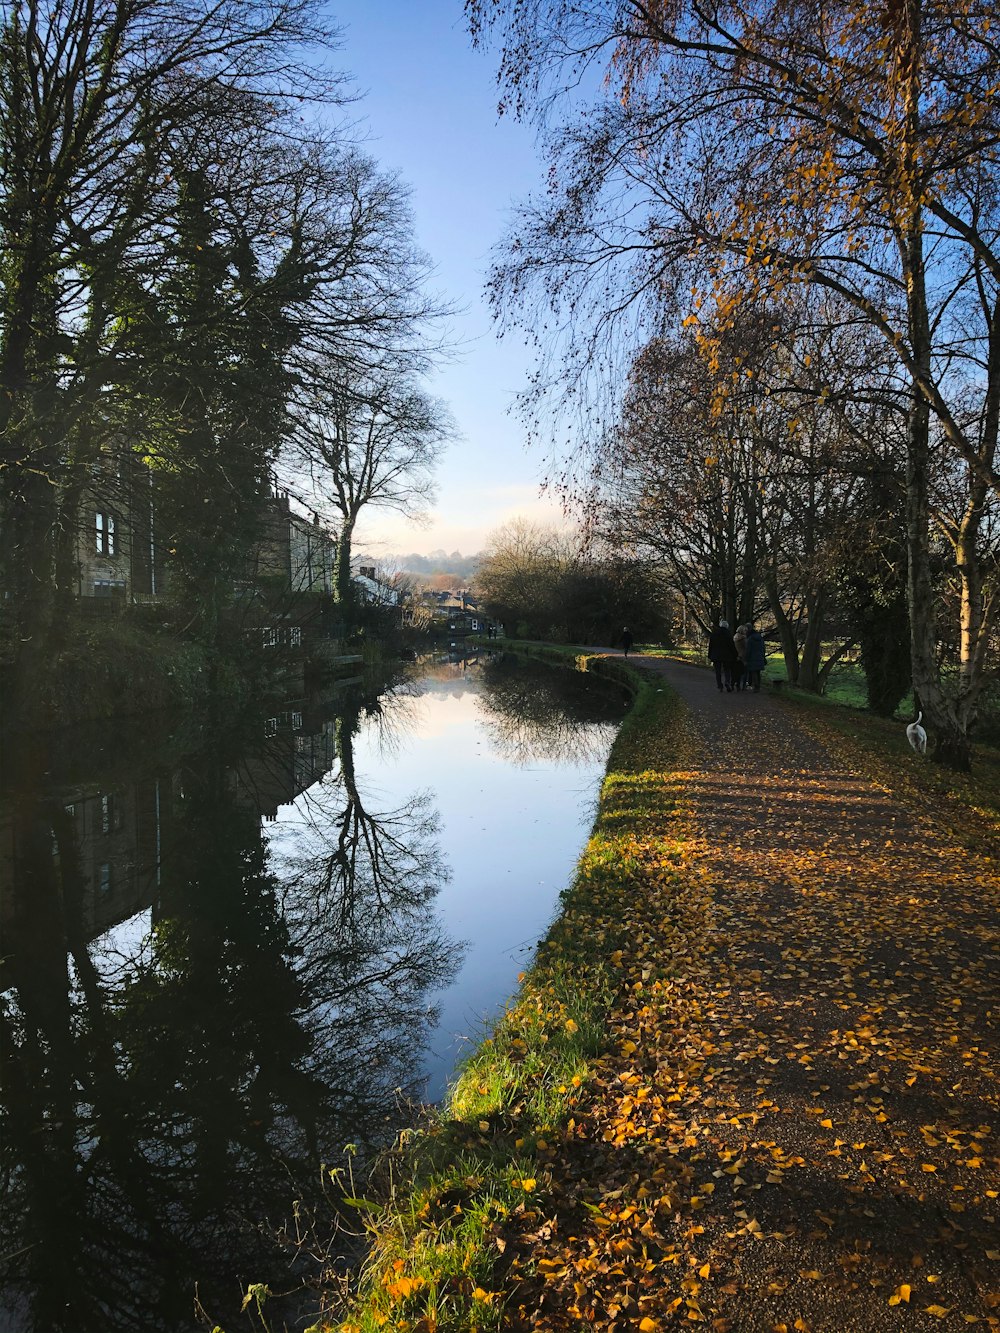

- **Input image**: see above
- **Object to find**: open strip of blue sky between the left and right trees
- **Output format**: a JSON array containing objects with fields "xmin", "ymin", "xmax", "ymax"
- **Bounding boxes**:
[{"xmin": 327, "ymin": 0, "xmax": 570, "ymax": 555}]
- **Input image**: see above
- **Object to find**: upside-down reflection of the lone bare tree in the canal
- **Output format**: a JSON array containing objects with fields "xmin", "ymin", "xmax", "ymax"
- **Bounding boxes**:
[{"xmin": 272, "ymin": 693, "xmax": 461, "ymax": 1096}]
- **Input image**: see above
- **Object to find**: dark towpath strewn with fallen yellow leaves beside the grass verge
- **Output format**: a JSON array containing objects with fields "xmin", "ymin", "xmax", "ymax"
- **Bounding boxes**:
[{"xmin": 512, "ymin": 657, "xmax": 1000, "ymax": 1333}]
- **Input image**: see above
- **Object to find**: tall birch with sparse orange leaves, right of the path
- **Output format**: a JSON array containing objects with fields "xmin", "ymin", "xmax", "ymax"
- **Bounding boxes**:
[{"xmin": 468, "ymin": 0, "xmax": 1000, "ymax": 766}]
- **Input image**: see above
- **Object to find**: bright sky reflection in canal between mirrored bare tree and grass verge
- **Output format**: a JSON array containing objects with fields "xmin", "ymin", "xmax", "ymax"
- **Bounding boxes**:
[{"xmin": 344, "ymin": 655, "xmax": 625, "ymax": 1101}]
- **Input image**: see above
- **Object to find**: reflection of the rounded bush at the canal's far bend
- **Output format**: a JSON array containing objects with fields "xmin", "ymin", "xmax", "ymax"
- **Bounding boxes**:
[{"xmin": 480, "ymin": 657, "xmax": 625, "ymax": 766}]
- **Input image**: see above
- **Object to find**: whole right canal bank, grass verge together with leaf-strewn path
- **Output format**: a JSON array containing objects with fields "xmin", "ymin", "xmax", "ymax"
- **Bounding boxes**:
[{"xmin": 328, "ymin": 661, "xmax": 1000, "ymax": 1333}]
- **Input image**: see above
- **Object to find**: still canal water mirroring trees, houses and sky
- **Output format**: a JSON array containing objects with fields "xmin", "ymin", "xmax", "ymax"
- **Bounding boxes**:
[{"xmin": 0, "ymin": 660, "xmax": 624, "ymax": 1333}]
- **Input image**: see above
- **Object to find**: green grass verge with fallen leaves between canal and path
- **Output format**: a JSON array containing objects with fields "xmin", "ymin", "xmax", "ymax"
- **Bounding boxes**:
[{"xmin": 325, "ymin": 658, "xmax": 688, "ymax": 1333}]
